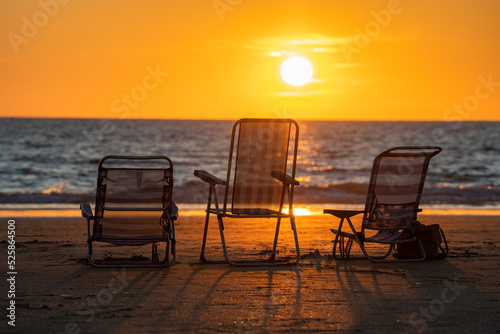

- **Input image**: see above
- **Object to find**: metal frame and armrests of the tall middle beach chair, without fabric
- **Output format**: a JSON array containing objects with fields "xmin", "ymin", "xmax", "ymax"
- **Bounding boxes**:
[{"xmin": 194, "ymin": 118, "xmax": 300, "ymax": 266}]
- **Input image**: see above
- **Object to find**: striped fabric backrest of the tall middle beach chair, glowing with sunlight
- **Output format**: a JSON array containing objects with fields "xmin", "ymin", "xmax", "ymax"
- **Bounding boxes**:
[{"xmin": 223, "ymin": 119, "xmax": 299, "ymax": 214}]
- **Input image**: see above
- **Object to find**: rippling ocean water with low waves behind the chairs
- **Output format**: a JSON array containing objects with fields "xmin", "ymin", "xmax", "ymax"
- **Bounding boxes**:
[{"xmin": 0, "ymin": 118, "xmax": 500, "ymax": 209}]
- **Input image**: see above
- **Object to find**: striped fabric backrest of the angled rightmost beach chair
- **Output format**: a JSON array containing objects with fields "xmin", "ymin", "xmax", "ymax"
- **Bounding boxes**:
[{"xmin": 363, "ymin": 146, "xmax": 442, "ymax": 229}]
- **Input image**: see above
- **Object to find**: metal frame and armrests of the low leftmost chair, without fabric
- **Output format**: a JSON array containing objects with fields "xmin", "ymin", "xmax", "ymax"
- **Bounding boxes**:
[{"xmin": 80, "ymin": 155, "xmax": 178, "ymax": 268}]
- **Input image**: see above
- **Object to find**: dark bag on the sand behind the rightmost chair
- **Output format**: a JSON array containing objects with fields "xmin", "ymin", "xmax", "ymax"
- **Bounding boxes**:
[{"xmin": 393, "ymin": 221, "xmax": 448, "ymax": 260}]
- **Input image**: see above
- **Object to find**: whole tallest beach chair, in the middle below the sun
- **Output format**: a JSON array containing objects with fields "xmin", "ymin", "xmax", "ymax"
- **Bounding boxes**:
[{"xmin": 194, "ymin": 119, "xmax": 300, "ymax": 266}]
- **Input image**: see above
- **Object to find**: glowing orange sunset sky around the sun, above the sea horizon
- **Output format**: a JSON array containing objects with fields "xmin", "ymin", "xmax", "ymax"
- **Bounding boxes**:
[{"xmin": 0, "ymin": 0, "xmax": 500, "ymax": 120}]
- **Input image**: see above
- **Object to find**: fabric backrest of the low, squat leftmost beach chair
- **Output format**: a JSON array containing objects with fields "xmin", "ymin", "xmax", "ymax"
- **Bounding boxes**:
[{"xmin": 96, "ymin": 155, "xmax": 173, "ymax": 218}]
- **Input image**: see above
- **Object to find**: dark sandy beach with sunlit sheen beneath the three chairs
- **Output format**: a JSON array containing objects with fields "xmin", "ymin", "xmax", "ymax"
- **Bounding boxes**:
[{"xmin": 0, "ymin": 215, "xmax": 500, "ymax": 333}]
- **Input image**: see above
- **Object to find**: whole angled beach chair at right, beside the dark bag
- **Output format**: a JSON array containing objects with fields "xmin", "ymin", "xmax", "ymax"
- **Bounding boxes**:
[{"xmin": 324, "ymin": 146, "xmax": 441, "ymax": 262}]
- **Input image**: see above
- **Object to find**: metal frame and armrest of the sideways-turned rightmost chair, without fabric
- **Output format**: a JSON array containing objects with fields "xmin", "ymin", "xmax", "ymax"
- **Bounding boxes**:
[{"xmin": 323, "ymin": 146, "xmax": 442, "ymax": 262}]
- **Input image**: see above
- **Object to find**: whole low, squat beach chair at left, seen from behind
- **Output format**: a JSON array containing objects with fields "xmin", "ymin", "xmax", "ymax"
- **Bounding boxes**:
[{"xmin": 80, "ymin": 155, "xmax": 178, "ymax": 267}]
